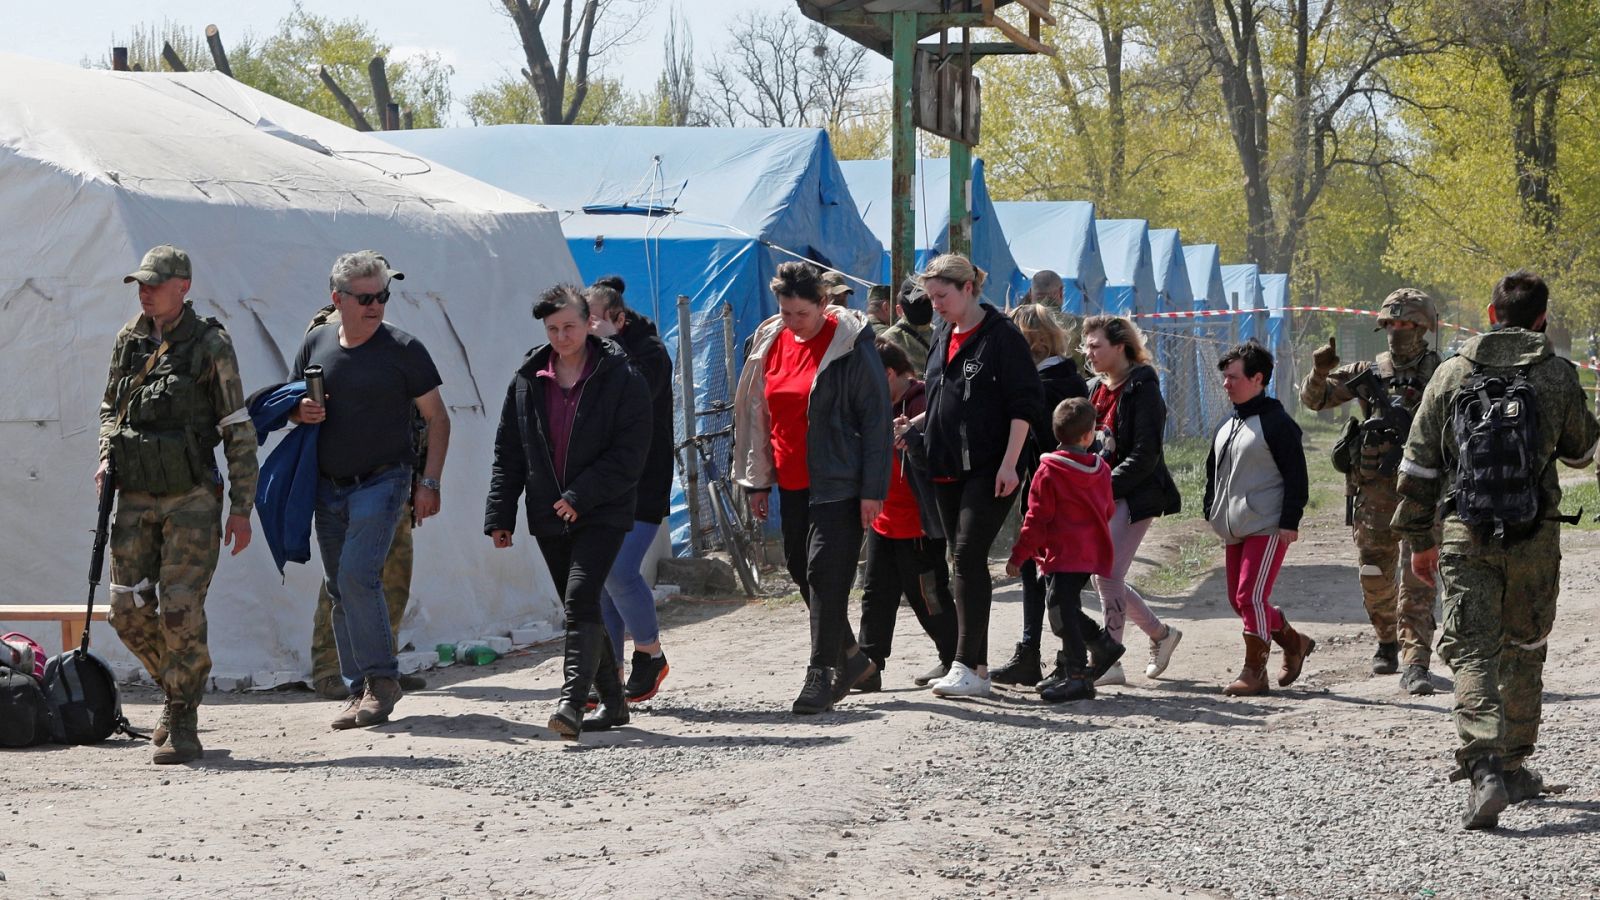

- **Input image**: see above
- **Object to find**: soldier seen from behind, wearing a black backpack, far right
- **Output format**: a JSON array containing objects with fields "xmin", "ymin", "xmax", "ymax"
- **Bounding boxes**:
[{"xmin": 1394, "ymin": 272, "xmax": 1600, "ymax": 828}]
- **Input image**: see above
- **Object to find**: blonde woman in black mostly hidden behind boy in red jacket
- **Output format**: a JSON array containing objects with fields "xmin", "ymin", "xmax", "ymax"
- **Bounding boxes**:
[{"xmin": 989, "ymin": 303, "xmax": 1099, "ymax": 689}]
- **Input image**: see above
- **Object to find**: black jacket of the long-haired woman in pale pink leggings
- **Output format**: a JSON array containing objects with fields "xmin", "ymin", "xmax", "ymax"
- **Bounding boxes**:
[{"xmin": 1088, "ymin": 364, "xmax": 1184, "ymax": 522}]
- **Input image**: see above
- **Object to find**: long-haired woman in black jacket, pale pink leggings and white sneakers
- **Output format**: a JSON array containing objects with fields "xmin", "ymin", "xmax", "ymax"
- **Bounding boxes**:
[{"xmin": 1083, "ymin": 315, "xmax": 1184, "ymax": 684}]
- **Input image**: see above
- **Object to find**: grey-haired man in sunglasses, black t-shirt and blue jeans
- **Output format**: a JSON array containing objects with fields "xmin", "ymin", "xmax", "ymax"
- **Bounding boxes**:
[{"xmin": 290, "ymin": 250, "xmax": 450, "ymax": 729}]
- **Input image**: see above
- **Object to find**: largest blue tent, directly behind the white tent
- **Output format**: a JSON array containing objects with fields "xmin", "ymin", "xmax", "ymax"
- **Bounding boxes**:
[{"xmin": 381, "ymin": 125, "xmax": 883, "ymax": 546}]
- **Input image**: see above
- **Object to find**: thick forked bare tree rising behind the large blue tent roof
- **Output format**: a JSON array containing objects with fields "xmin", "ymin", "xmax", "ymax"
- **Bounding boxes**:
[{"xmin": 501, "ymin": 0, "xmax": 654, "ymax": 125}]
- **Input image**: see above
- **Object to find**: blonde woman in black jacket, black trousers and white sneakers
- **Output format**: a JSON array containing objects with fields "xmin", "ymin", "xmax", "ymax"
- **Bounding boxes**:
[{"xmin": 896, "ymin": 253, "xmax": 1045, "ymax": 697}]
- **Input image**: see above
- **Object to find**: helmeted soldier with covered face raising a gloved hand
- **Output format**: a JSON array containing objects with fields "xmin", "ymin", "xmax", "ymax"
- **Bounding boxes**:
[{"xmin": 1301, "ymin": 288, "xmax": 1440, "ymax": 693}]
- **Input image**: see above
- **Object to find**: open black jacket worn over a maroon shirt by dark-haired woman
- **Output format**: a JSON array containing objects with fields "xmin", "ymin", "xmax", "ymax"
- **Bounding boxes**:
[{"xmin": 483, "ymin": 335, "xmax": 650, "ymax": 536}]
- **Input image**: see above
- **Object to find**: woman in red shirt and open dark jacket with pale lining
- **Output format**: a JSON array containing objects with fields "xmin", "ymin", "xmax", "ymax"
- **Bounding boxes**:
[{"xmin": 733, "ymin": 263, "xmax": 890, "ymax": 716}]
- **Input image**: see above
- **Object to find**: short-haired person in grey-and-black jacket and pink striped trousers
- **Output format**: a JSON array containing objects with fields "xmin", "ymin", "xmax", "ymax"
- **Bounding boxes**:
[{"xmin": 1205, "ymin": 341, "xmax": 1317, "ymax": 697}]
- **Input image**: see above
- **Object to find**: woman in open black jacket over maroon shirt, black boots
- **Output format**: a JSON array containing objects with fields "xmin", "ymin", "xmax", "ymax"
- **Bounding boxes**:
[{"xmin": 483, "ymin": 285, "xmax": 650, "ymax": 740}]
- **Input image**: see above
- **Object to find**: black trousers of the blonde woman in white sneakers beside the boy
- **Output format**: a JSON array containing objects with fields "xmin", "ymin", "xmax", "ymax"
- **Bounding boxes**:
[{"xmin": 933, "ymin": 469, "xmax": 1018, "ymax": 669}]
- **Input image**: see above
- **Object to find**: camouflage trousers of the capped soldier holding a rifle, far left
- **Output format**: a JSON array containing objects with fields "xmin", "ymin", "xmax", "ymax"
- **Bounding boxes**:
[{"xmin": 107, "ymin": 484, "xmax": 222, "ymax": 705}]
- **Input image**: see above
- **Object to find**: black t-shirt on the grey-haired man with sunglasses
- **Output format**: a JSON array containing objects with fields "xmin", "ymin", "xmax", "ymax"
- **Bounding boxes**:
[{"xmin": 291, "ymin": 322, "xmax": 442, "ymax": 479}]
